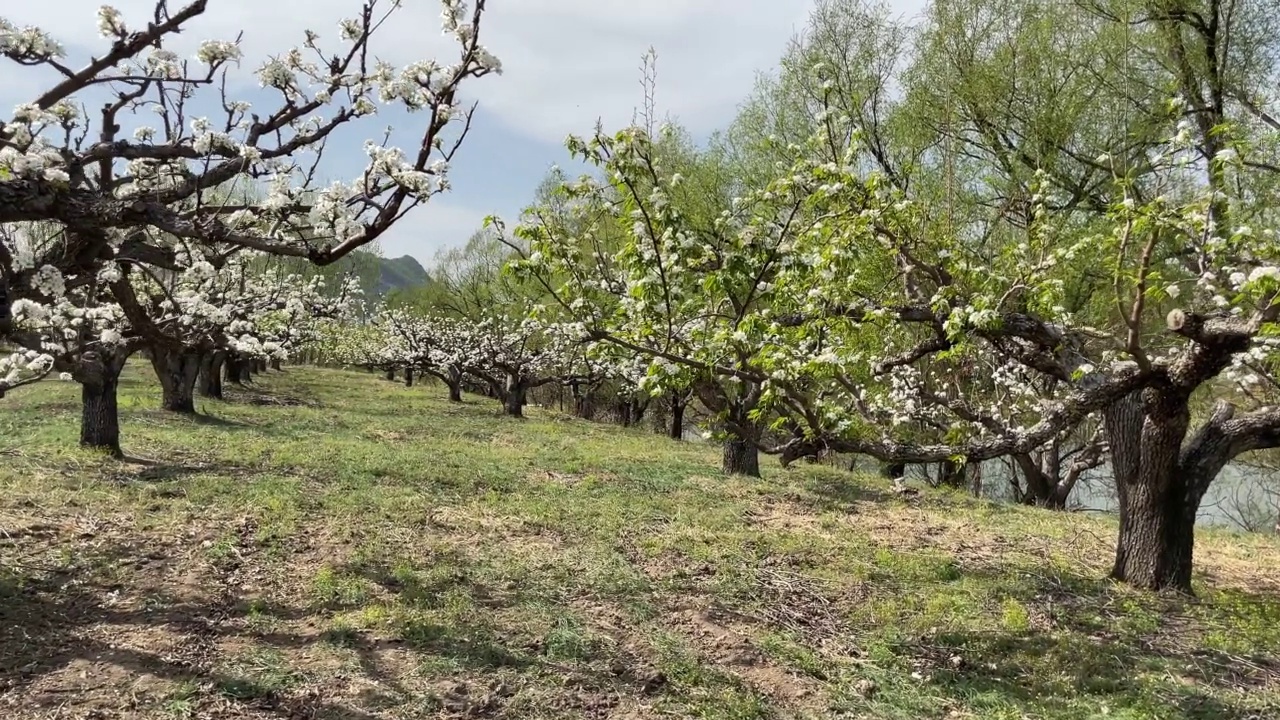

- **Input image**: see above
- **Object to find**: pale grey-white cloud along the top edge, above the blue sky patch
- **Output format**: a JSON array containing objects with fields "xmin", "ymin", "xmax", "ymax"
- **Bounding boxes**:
[{"xmin": 4, "ymin": 0, "xmax": 810, "ymax": 143}]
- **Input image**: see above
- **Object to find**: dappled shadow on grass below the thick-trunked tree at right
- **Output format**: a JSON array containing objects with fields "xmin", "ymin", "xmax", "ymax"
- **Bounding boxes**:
[{"xmin": 896, "ymin": 568, "xmax": 1280, "ymax": 720}]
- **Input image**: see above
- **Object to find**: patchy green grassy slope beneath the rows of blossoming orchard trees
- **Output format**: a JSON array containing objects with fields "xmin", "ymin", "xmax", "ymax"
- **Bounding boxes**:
[{"xmin": 0, "ymin": 365, "xmax": 1280, "ymax": 720}]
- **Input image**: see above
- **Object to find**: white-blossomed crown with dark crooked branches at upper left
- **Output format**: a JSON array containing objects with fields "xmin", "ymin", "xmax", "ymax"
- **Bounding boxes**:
[{"xmin": 0, "ymin": 0, "xmax": 502, "ymax": 404}]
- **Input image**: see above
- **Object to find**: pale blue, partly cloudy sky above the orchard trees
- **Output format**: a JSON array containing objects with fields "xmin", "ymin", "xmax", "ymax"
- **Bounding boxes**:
[{"xmin": 0, "ymin": 0, "xmax": 923, "ymax": 266}]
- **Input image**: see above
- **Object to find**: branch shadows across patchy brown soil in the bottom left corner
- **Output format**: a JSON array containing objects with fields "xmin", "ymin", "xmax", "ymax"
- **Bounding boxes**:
[{"xmin": 0, "ymin": 536, "xmax": 660, "ymax": 720}]
